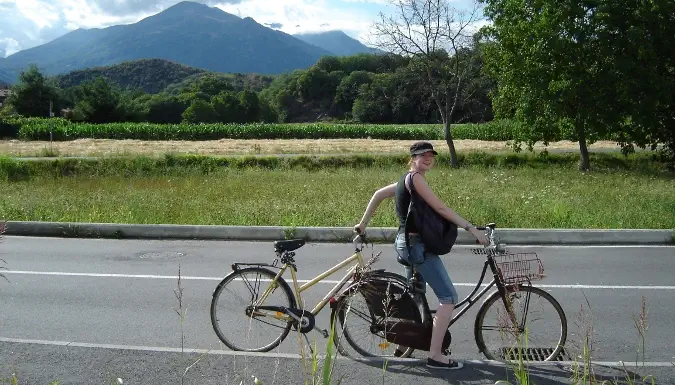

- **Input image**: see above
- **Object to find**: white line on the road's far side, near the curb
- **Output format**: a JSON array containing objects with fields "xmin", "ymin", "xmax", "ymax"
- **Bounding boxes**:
[{"xmin": 2, "ymin": 270, "xmax": 675, "ymax": 290}]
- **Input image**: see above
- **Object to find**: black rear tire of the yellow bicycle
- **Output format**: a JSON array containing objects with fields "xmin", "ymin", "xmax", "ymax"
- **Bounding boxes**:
[{"xmin": 210, "ymin": 267, "xmax": 296, "ymax": 352}]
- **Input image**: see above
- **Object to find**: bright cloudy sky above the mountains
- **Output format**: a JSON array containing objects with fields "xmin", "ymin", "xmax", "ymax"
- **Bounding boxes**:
[{"xmin": 0, "ymin": 0, "xmax": 480, "ymax": 57}]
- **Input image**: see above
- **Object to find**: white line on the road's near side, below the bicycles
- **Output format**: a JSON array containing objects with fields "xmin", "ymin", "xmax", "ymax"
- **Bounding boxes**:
[{"xmin": 0, "ymin": 337, "xmax": 675, "ymax": 369}]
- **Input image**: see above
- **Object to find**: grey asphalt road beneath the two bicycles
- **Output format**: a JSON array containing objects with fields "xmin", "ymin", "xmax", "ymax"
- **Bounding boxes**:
[{"xmin": 0, "ymin": 237, "xmax": 675, "ymax": 384}]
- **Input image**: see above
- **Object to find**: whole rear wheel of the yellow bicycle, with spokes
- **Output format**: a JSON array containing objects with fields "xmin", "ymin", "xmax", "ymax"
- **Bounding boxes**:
[{"xmin": 211, "ymin": 267, "xmax": 295, "ymax": 352}]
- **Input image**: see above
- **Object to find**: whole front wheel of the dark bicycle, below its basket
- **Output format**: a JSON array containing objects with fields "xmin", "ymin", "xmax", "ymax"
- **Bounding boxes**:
[{"xmin": 474, "ymin": 285, "xmax": 567, "ymax": 361}]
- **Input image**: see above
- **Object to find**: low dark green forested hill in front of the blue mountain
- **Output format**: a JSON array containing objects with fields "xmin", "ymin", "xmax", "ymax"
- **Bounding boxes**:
[{"xmin": 55, "ymin": 59, "xmax": 274, "ymax": 94}]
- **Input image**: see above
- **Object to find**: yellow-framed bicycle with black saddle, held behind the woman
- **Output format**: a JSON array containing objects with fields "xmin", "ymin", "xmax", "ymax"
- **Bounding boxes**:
[{"xmin": 211, "ymin": 231, "xmax": 390, "ymax": 352}]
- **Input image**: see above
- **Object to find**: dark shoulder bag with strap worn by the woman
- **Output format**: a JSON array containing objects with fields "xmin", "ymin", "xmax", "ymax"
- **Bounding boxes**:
[{"xmin": 405, "ymin": 172, "xmax": 457, "ymax": 255}]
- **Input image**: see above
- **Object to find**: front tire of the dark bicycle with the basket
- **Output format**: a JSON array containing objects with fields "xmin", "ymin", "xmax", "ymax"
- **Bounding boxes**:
[{"xmin": 474, "ymin": 285, "xmax": 567, "ymax": 361}]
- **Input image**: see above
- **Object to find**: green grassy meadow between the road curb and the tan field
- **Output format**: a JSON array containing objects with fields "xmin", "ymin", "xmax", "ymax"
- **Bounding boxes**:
[{"xmin": 0, "ymin": 155, "xmax": 675, "ymax": 228}]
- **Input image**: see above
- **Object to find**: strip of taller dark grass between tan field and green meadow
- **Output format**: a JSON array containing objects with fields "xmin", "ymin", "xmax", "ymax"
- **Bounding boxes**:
[{"xmin": 0, "ymin": 151, "xmax": 675, "ymax": 181}]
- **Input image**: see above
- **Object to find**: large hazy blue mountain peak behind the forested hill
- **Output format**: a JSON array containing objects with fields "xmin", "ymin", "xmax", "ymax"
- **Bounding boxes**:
[{"xmin": 0, "ymin": 1, "xmax": 331, "ymax": 80}]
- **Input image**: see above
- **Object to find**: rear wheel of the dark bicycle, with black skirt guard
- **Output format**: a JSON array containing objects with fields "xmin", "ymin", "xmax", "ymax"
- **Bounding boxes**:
[{"xmin": 331, "ymin": 272, "xmax": 422, "ymax": 358}]
